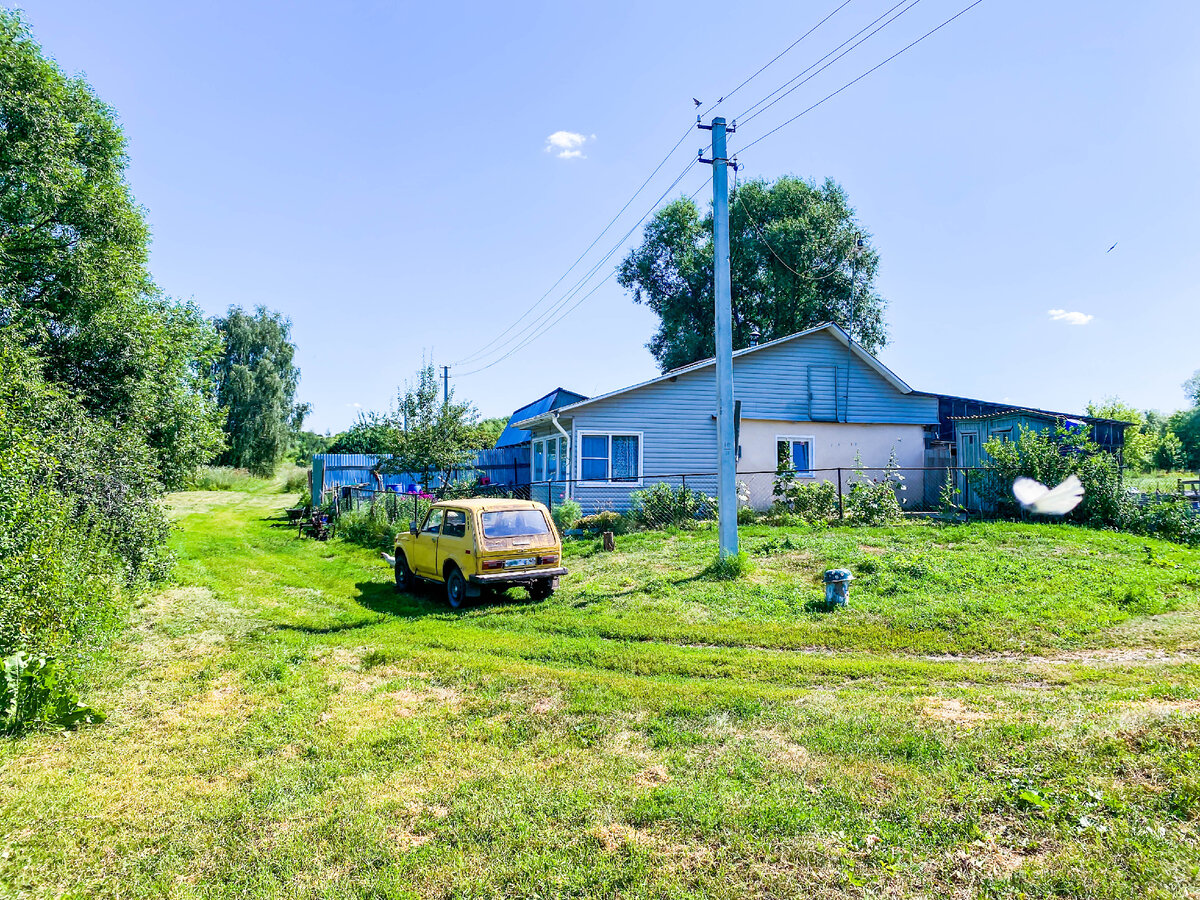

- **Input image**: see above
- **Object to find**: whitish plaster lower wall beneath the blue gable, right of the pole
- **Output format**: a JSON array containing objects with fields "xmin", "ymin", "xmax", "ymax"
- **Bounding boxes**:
[{"xmin": 738, "ymin": 419, "xmax": 925, "ymax": 508}]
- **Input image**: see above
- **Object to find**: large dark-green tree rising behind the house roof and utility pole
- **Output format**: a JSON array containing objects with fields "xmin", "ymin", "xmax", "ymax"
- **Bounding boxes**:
[{"xmin": 617, "ymin": 176, "xmax": 887, "ymax": 371}]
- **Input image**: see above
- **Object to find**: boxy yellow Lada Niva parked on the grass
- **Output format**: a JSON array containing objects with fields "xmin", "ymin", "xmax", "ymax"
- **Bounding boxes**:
[{"xmin": 396, "ymin": 498, "xmax": 566, "ymax": 610}]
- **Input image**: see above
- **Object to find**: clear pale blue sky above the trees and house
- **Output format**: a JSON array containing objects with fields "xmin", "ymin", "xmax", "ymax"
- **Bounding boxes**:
[{"xmin": 20, "ymin": 0, "xmax": 1200, "ymax": 431}]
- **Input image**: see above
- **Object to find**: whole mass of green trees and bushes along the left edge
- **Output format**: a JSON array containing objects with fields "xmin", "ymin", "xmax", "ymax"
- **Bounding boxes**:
[{"xmin": 0, "ymin": 11, "xmax": 238, "ymax": 730}]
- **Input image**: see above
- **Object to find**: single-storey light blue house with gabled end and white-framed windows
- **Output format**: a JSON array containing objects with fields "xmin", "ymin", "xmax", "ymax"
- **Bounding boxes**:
[{"xmin": 514, "ymin": 323, "xmax": 938, "ymax": 512}]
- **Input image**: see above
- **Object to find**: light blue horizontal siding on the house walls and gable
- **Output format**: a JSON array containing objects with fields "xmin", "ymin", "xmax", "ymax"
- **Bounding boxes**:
[{"xmin": 535, "ymin": 331, "xmax": 937, "ymax": 509}]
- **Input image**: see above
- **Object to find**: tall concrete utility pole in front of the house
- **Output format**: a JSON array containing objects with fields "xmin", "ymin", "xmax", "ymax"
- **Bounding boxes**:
[{"xmin": 696, "ymin": 116, "xmax": 738, "ymax": 559}]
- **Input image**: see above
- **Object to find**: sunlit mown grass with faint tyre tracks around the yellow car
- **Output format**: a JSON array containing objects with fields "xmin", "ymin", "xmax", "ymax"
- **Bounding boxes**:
[{"xmin": 0, "ymin": 491, "xmax": 1200, "ymax": 900}]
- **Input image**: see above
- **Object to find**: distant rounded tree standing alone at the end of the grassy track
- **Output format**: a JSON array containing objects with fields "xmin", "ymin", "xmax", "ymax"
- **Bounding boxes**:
[{"xmin": 212, "ymin": 306, "xmax": 307, "ymax": 476}]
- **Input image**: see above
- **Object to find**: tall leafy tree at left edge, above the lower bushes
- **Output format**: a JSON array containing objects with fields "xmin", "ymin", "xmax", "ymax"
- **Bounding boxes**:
[{"xmin": 0, "ymin": 11, "xmax": 220, "ymax": 487}]
